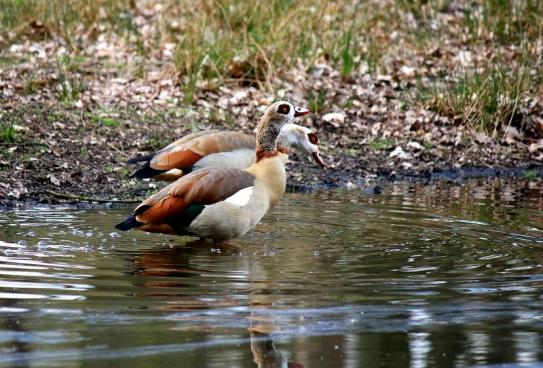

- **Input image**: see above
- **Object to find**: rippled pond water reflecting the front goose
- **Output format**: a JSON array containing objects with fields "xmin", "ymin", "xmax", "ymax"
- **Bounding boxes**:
[{"xmin": 0, "ymin": 181, "xmax": 543, "ymax": 368}]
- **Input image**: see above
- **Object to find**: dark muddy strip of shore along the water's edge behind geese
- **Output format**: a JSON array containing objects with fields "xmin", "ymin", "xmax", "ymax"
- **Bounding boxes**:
[{"xmin": 0, "ymin": 99, "xmax": 543, "ymax": 208}]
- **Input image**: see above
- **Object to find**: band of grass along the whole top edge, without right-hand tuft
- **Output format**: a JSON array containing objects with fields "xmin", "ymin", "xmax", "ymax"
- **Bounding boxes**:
[{"xmin": 0, "ymin": 0, "xmax": 543, "ymax": 89}]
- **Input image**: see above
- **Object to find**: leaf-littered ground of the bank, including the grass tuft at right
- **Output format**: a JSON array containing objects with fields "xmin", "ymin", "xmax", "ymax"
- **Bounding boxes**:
[{"xmin": 0, "ymin": 1, "xmax": 543, "ymax": 206}]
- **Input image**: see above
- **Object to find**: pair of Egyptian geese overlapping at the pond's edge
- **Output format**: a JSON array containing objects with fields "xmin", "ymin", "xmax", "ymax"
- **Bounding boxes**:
[{"xmin": 116, "ymin": 101, "xmax": 324, "ymax": 242}]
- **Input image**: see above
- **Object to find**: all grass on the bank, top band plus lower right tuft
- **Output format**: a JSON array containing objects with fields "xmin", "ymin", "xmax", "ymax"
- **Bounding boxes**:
[{"xmin": 0, "ymin": 0, "xmax": 543, "ymax": 131}]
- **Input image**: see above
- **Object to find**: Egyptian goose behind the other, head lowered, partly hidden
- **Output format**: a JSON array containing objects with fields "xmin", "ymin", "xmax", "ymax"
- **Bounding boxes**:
[{"xmin": 128, "ymin": 124, "xmax": 325, "ymax": 181}]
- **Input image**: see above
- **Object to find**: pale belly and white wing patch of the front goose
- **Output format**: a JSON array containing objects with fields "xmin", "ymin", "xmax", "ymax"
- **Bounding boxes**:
[{"xmin": 188, "ymin": 186, "xmax": 270, "ymax": 240}]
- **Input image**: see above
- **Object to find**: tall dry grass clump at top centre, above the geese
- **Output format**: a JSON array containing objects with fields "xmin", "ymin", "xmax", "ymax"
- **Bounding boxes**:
[{"xmin": 172, "ymin": 0, "xmax": 370, "ymax": 95}]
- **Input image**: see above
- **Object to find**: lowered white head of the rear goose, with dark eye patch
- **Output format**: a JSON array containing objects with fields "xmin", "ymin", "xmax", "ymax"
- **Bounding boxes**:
[{"xmin": 277, "ymin": 123, "xmax": 326, "ymax": 168}]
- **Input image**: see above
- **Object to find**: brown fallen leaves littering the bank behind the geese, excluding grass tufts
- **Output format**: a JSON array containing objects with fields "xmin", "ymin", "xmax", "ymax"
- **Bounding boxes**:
[{"xmin": 0, "ymin": 2, "xmax": 543, "ymax": 206}]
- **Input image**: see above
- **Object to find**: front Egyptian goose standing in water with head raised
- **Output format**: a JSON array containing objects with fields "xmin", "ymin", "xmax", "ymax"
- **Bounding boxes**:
[{"xmin": 116, "ymin": 101, "xmax": 309, "ymax": 241}]
